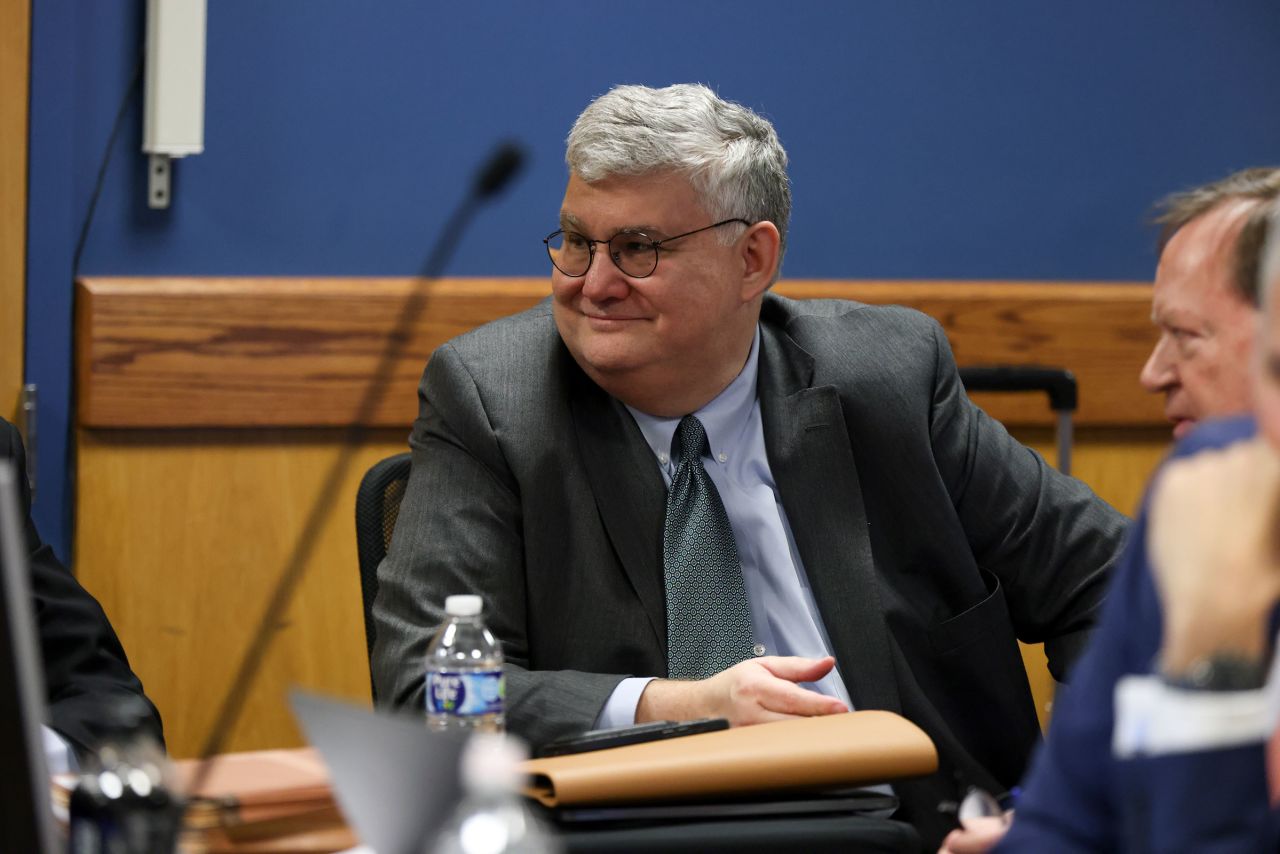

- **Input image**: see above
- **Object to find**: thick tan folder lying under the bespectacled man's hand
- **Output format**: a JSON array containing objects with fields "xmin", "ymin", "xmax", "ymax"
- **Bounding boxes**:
[{"xmin": 525, "ymin": 711, "xmax": 938, "ymax": 807}]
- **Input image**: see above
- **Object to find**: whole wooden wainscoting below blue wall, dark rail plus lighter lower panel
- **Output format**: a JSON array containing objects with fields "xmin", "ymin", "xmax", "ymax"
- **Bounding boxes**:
[{"xmin": 77, "ymin": 279, "xmax": 1169, "ymax": 755}]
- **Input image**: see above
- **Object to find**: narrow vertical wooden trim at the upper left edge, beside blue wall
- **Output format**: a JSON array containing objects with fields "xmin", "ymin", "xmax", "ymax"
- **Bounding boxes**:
[{"xmin": 0, "ymin": 0, "xmax": 31, "ymax": 421}]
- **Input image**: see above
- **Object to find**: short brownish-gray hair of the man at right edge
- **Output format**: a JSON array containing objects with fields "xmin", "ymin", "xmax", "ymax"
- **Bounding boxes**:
[{"xmin": 1155, "ymin": 166, "xmax": 1280, "ymax": 306}]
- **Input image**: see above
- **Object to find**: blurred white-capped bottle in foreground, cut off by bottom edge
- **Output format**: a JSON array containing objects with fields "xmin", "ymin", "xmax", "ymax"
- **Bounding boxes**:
[{"xmin": 425, "ymin": 734, "xmax": 563, "ymax": 854}]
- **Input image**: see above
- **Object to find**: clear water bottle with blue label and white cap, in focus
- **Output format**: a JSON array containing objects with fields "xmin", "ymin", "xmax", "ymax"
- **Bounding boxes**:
[{"xmin": 426, "ymin": 595, "xmax": 506, "ymax": 732}]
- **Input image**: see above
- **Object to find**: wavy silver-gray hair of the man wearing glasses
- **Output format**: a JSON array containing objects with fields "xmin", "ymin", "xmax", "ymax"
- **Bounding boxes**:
[{"xmin": 564, "ymin": 83, "xmax": 791, "ymax": 270}]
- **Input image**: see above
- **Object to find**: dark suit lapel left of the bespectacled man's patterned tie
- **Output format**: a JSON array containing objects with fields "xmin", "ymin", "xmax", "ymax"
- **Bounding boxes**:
[{"xmin": 564, "ymin": 352, "xmax": 667, "ymax": 661}]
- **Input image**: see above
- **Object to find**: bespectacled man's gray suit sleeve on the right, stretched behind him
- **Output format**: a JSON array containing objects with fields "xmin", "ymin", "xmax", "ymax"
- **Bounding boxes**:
[{"xmin": 929, "ymin": 324, "xmax": 1126, "ymax": 682}]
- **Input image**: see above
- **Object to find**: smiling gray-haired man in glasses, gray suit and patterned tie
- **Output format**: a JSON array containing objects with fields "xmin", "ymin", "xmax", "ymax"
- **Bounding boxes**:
[{"xmin": 372, "ymin": 86, "xmax": 1124, "ymax": 842}]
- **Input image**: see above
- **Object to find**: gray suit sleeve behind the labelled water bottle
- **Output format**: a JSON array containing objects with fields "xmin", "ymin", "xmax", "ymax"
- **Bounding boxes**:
[{"xmin": 371, "ymin": 344, "xmax": 626, "ymax": 744}]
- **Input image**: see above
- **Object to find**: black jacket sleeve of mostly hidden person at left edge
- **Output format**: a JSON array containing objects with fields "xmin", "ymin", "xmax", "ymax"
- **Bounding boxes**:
[{"xmin": 0, "ymin": 421, "xmax": 163, "ymax": 753}]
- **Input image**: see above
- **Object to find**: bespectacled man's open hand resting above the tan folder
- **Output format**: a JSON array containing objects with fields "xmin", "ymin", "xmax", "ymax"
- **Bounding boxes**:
[{"xmin": 636, "ymin": 656, "xmax": 849, "ymax": 726}]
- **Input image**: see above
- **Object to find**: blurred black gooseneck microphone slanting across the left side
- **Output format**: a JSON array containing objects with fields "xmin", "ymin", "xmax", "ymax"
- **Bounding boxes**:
[{"xmin": 189, "ymin": 141, "xmax": 525, "ymax": 793}]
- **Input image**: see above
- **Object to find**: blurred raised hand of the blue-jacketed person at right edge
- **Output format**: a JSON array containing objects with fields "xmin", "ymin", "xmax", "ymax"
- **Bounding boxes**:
[{"xmin": 1147, "ymin": 439, "xmax": 1280, "ymax": 673}]
